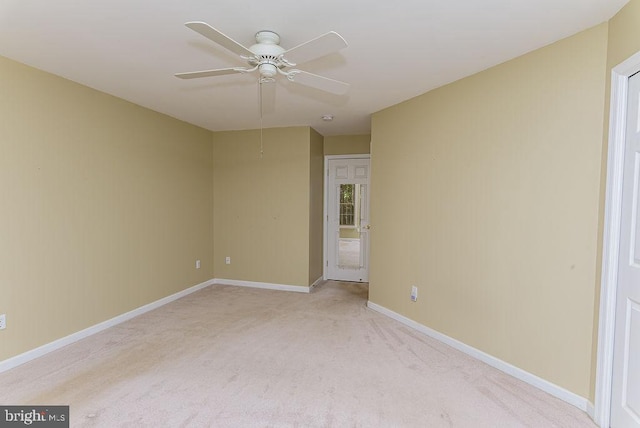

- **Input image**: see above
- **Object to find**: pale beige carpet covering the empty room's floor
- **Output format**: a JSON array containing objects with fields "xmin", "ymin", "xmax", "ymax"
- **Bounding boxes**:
[{"xmin": 0, "ymin": 282, "xmax": 595, "ymax": 428}]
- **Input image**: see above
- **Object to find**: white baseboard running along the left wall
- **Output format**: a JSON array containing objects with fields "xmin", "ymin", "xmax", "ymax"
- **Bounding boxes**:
[{"xmin": 0, "ymin": 280, "xmax": 213, "ymax": 373}]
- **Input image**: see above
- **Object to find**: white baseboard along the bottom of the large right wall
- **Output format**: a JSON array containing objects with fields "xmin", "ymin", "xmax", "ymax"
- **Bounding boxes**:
[{"xmin": 367, "ymin": 301, "xmax": 593, "ymax": 415}]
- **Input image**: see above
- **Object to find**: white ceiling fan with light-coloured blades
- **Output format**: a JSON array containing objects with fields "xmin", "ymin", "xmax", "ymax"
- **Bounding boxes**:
[{"xmin": 175, "ymin": 21, "xmax": 349, "ymax": 95}]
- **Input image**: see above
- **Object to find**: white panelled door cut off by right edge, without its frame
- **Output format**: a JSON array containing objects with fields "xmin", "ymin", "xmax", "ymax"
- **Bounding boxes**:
[{"xmin": 611, "ymin": 74, "xmax": 640, "ymax": 428}]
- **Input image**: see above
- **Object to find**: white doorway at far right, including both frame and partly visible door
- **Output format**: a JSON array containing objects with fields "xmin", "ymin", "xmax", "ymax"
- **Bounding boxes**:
[{"xmin": 594, "ymin": 49, "xmax": 640, "ymax": 428}]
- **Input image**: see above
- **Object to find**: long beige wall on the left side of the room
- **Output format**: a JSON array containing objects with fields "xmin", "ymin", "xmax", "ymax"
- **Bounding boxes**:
[{"xmin": 0, "ymin": 58, "xmax": 213, "ymax": 360}]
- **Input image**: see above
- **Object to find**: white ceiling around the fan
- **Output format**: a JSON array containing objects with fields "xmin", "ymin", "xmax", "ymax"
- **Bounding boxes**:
[{"xmin": 0, "ymin": 0, "xmax": 628, "ymax": 135}]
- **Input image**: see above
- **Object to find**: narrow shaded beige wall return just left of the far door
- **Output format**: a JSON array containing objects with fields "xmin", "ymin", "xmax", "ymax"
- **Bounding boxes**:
[{"xmin": 309, "ymin": 128, "xmax": 324, "ymax": 285}]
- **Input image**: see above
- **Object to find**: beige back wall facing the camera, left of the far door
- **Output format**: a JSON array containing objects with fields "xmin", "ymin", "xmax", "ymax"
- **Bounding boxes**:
[{"xmin": 213, "ymin": 127, "xmax": 319, "ymax": 286}]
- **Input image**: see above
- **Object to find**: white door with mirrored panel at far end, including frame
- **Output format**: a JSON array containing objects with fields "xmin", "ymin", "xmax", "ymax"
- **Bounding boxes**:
[{"xmin": 326, "ymin": 158, "xmax": 370, "ymax": 282}]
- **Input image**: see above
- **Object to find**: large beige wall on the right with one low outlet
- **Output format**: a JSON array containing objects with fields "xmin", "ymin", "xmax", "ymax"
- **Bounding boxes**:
[{"xmin": 370, "ymin": 24, "xmax": 607, "ymax": 397}]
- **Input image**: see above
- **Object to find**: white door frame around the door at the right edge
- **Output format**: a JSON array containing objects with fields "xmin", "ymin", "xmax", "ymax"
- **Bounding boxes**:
[{"xmin": 592, "ymin": 52, "xmax": 640, "ymax": 428}]
